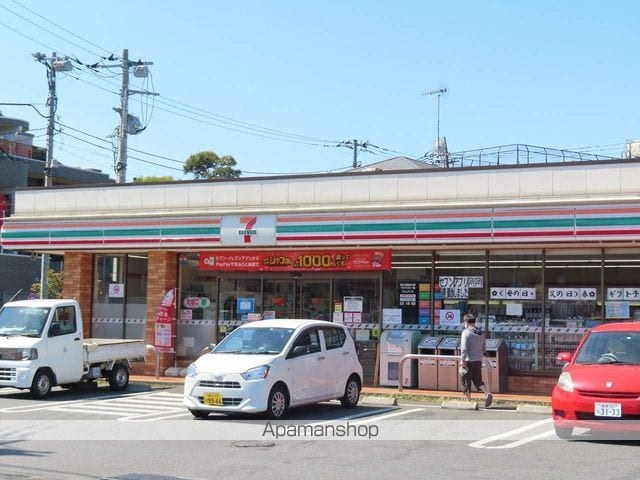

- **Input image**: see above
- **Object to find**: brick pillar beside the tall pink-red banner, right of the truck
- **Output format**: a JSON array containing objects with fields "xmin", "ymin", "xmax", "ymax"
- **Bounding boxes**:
[{"xmin": 141, "ymin": 251, "xmax": 178, "ymax": 375}]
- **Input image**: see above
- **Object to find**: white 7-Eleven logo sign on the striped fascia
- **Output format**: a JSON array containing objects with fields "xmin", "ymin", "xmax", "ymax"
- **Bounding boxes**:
[{"xmin": 220, "ymin": 215, "xmax": 276, "ymax": 247}]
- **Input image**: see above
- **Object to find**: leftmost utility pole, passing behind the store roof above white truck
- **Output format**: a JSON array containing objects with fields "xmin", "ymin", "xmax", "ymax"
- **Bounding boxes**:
[{"xmin": 33, "ymin": 52, "xmax": 73, "ymax": 298}]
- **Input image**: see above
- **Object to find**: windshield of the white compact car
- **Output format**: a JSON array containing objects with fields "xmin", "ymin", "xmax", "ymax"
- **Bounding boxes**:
[{"xmin": 212, "ymin": 327, "xmax": 295, "ymax": 355}]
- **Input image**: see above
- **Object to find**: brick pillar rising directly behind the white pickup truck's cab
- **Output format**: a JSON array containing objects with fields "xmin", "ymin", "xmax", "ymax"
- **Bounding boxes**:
[{"xmin": 62, "ymin": 252, "xmax": 93, "ymax": 338}]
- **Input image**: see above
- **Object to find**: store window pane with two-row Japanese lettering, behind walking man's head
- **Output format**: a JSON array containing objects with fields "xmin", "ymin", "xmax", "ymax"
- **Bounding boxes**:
[{"xmin": 434, "ymin": 251, "xmax": 487, "ymax": 333}]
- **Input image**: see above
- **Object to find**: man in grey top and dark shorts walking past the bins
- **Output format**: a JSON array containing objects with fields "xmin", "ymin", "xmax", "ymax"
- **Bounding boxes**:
[{"xmin": 460, "ymin": 313, "xmax": 493, "ymax": 407}]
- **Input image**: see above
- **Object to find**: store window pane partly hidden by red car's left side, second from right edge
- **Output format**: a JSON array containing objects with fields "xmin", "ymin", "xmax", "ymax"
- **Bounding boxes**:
[{"xmin": 544, "ymin": 249, "xmax": 602, "ymax": 371}]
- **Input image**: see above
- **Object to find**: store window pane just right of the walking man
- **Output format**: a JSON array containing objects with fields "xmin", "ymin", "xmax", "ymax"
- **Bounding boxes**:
[{"xmin": 490, "ymin": 250, "xmax": 544, "ymax": 372}]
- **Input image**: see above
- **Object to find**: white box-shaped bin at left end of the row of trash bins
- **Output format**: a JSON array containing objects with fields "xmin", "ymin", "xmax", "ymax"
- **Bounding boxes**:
[{"xmin": 380, "ymin": 330, "xmax": 420, "ymax": 388}]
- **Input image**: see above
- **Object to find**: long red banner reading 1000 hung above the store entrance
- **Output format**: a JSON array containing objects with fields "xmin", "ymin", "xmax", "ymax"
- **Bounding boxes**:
[{"xmin": 199, "ymin": 249, "xmax": 391, "ymax": 272}]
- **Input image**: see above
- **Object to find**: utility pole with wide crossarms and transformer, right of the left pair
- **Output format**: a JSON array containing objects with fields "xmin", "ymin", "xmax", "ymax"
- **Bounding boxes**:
[{"xmin": 95, "ymin": 48, "xmax": 158, "ymax": 183}]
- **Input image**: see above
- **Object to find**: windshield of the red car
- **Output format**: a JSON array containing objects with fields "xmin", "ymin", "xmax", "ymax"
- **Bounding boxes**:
[{"xmin": 575, "ymin": 332, "xmax": 640, "ymax": 365}]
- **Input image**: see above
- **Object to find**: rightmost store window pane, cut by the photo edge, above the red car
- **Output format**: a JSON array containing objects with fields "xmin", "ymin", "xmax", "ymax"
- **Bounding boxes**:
[{"xmin": 604, "ymin": 248, "xmax": 640, "ymax": 322}]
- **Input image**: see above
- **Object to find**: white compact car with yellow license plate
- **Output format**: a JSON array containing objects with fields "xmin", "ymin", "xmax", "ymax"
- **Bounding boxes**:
[{"xmin": 184, "ymin": 320, "xmax": 362, "ymax": 419}]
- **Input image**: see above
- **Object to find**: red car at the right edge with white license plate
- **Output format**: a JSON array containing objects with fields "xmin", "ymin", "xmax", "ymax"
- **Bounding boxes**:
[{"xmin": 551, "ymin": 322, "xmax": 640, "ymax": 439}]
